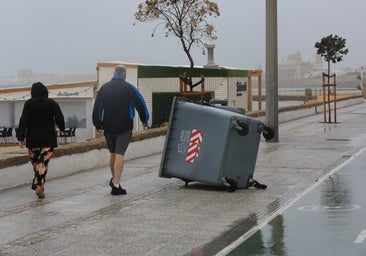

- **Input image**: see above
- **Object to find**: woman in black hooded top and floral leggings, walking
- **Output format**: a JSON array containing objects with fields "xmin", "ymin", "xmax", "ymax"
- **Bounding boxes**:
[{"xmin": 16, "ymin": 82, "xmax": 65, "ymax": 198}]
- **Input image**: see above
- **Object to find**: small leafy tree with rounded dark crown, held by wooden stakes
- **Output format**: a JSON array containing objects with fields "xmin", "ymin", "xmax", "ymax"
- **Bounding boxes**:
[{"xmin": 315, "ymin": 34, "xmax": 348, "ymax": 123}]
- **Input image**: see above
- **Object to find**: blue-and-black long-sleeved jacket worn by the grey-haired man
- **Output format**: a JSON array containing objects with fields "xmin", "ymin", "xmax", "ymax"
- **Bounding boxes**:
[{"xmin": 93, "ymin": 76, "xmax": 149, "ymax": 134}]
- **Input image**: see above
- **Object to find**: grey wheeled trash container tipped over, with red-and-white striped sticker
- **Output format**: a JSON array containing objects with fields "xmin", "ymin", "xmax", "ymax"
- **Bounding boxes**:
[{"xmin": 159, "ymin": 97, "xmax": 273, "ymax": 192}]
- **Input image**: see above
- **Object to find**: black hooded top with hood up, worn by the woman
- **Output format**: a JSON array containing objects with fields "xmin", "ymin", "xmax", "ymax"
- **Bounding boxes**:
[{"xmin": 17, "ymin": 82, "xmax": 65, "ymax": 149}]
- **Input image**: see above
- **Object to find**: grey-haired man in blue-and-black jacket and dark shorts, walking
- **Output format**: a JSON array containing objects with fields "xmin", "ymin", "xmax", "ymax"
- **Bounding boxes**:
[{"xmin": 93, "ymin": 65, "xmax": 149, "ymax": 195}]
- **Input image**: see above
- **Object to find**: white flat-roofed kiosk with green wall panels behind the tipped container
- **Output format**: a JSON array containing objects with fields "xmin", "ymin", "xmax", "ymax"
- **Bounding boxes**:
[{"xmin": 97, "ymin": 61, "xmax": 261, "ymax": 129}]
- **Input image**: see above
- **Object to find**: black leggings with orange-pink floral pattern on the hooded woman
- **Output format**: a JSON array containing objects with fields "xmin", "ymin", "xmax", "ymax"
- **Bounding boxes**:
[{"xmin": 28, "ymin": 148, "xmax": 53, "ymax": 190}]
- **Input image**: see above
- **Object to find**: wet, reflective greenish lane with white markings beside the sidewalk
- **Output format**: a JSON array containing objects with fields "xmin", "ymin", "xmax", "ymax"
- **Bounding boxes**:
[{"xmin": 224, "ymin": 149, "xmax": 366, "ymax": 256}]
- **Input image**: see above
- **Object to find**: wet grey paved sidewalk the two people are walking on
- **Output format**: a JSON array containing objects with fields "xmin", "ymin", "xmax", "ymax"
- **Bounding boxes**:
[{"xmin": 0, "ymin": 103, "xmax": 366, "ymax": 256}]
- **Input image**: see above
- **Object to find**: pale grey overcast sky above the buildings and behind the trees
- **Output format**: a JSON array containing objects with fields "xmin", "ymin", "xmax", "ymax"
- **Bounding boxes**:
[{"xmin": 0, "ymin": 0, "xmax": 366, "ymax": 77}]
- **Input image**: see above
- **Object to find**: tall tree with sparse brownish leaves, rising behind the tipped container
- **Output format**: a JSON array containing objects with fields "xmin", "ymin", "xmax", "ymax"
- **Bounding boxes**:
[{"xmin": 135, "ymin": 0, "xmax": 220, "ymax": 90}]
